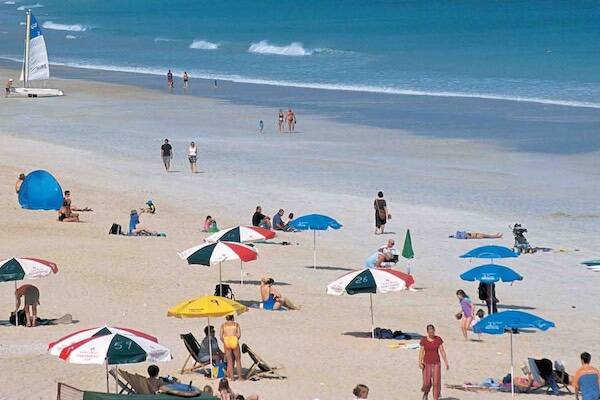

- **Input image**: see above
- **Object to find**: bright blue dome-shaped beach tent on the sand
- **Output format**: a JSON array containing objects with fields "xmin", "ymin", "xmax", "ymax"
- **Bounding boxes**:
[{"xmin": 19, "ymin": 170, "xmax": 63, "ymax": 210}]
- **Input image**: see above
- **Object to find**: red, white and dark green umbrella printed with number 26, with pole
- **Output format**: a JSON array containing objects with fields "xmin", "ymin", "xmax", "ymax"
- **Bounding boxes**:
[{"xmin": 327, "ymin": 268, "xmax": 415, "ymax": 338}]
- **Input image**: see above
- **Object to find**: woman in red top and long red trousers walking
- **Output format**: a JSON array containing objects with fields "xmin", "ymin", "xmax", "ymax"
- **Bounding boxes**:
[{"xmin": 419, "ymin": 325, "xmax": 450, "ymax": 400}]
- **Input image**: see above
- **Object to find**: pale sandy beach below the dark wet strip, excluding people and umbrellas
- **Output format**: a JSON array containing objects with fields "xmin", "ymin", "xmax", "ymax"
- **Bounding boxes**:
[{"xmin": 0, "ymin": 69, "xmax": 600, "ymax": 400}]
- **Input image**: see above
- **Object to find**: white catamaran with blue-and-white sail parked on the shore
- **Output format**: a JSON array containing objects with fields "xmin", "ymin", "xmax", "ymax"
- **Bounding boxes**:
[{"xmin": 10, "ymin": 10, "xmax": 64, "ymax": 97}]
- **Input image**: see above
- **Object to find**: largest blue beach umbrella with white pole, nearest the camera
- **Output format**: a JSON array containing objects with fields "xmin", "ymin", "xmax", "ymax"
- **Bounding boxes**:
[{"xmin": 473, "ymin": 310, "xmax": 556, "ymax": 396}]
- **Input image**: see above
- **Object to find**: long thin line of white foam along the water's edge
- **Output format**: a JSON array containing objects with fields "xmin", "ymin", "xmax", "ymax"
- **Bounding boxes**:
[{"xmin": 0, "ymin": 57, "xmax": 600, "ymax": 109}]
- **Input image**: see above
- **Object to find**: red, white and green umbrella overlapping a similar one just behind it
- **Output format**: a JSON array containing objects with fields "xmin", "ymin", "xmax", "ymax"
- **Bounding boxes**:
[{"xmin": 179, "ymin": 242, "xmax": 258, "ymax": 292}]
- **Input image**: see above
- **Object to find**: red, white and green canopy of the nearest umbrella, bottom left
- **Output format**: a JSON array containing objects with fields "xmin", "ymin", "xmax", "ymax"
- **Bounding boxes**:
[{"xmin": 59, "ymin": 333, "xmax": 171, "ymax": 365}]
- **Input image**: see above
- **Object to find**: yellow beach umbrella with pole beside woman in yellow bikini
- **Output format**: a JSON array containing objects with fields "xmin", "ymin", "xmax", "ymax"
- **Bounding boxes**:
[{"xmin": 167, "ymin": 296, "xmax": 248, "ymax": 378}]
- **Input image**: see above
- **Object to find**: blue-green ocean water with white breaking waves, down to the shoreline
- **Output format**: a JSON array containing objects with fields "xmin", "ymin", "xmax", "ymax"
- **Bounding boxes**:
[{"xmin": 0, "ymin": 0, "xmax": 600, "ymax": 108}]
